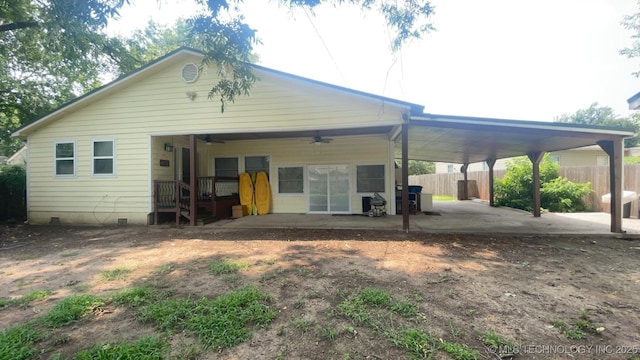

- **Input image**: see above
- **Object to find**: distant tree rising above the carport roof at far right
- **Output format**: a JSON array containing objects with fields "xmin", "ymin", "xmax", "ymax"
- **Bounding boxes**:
[{"xmin": 554, "ymin": 103, "xmax": 640, "ymax": 147}]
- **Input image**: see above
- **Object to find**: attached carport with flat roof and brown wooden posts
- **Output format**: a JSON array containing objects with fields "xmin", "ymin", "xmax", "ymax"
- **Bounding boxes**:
[{"xmin": 393, "ymin": 114, "xmax": 634, "ymax": 233}]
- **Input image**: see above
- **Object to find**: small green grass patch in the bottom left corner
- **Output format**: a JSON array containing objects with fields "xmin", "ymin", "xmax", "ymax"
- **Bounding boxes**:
[{"xmin": 0, "ymin": 324, "xmax": 42, "ymax": 360}]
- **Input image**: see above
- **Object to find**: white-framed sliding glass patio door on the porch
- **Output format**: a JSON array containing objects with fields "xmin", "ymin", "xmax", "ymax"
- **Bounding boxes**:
[{"xmin": 307, "ymin": 165, "xmax": 351, "ymax": 214}]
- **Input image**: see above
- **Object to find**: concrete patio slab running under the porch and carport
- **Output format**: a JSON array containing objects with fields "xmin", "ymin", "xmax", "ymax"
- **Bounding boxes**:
[{"xmin": 207, "ymin": 201, "xmax": 640, "ymax": 236}]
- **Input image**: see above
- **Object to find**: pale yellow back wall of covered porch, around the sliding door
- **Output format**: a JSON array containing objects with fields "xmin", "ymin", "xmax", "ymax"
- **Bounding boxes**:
[{"xmin": 154, "ymin": 135, "xmax": 394, "ymax": 213}]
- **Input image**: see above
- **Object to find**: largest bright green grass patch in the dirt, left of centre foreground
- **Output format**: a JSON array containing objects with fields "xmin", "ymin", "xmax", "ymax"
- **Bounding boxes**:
[{"xmin": 140, "ymin": 288, "xmax": 276, "ymax": 349}]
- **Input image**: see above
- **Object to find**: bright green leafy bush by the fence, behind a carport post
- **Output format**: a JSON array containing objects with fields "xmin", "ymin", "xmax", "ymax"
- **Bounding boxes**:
[{"xmin": 495, "ymin": 154, "xmax": 592, "ymax": 212}]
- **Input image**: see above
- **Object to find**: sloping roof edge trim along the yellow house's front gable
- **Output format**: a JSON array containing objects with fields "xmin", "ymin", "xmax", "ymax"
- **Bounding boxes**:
[{"xmin": 11, "ymin": 46, "xmax": 424, "ymax": 137}]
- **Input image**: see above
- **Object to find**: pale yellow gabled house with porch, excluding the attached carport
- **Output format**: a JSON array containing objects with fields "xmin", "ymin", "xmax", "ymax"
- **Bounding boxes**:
[{"xmin": 12, "ymin": 48, "xmax": 423, "ymax": 224}]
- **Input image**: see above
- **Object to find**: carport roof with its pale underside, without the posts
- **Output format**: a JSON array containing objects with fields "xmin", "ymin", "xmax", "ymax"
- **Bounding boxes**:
[{"xmin": 395, "ymin": 114, "xmax": 633, "ymax": 164}]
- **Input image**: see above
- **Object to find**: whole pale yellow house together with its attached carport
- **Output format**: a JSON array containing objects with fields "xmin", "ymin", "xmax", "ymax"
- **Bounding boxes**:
[{"xmin": 13, "ymin": 48, "xmax": 633, "ymax": 232}]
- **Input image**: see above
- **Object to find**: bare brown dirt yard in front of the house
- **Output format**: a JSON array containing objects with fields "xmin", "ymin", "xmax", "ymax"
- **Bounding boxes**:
[{"xmin": 0, "ymin": 226, "xmax": 640, "ymax": 359}]
